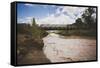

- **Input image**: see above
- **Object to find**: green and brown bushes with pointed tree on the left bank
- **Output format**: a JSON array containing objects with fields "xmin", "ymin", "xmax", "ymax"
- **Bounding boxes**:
[{"xmin": 17, "ymin": 18, "xmax": 48, "ymax": 63}]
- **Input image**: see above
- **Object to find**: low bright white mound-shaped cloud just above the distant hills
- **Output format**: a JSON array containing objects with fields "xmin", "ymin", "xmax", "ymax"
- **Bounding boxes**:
[{"xmin": 37, "ymin": 14, "xmax": 74, "ymax": 24}]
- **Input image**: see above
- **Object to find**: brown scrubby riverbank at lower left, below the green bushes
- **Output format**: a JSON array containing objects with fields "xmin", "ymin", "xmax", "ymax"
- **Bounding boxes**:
[{"xmin": 17, "ymin": 34, "xmax": 50, "ymax": 65}]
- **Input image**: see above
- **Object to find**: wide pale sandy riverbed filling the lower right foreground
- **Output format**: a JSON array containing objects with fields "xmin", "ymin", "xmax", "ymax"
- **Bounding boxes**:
[{"xmin": 43, "ymin": 33, "xmax": 96, "ymax": 62}]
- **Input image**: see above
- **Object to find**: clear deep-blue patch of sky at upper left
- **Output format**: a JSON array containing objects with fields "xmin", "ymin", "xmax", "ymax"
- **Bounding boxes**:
[{"xmin": 17, "ymin": 3, "xmax": 57, "ymax": 23}]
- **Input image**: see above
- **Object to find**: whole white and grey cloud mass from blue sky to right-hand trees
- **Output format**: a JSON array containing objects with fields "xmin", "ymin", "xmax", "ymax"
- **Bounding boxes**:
[{"xmin": 37, "ymin": 6, "xmax": 86, "ymax": 24}]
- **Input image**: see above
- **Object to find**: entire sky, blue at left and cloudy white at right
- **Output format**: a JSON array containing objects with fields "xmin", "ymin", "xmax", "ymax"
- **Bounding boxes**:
[{"xmin": 17, "ymin": 3, "xmax": 87, "ymax": 24}]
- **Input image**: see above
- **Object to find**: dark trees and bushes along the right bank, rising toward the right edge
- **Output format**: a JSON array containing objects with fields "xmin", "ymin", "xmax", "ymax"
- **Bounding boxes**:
[{"xmin": 59, "ymin": 7, "xmax": 96, "ymax": 37}]
